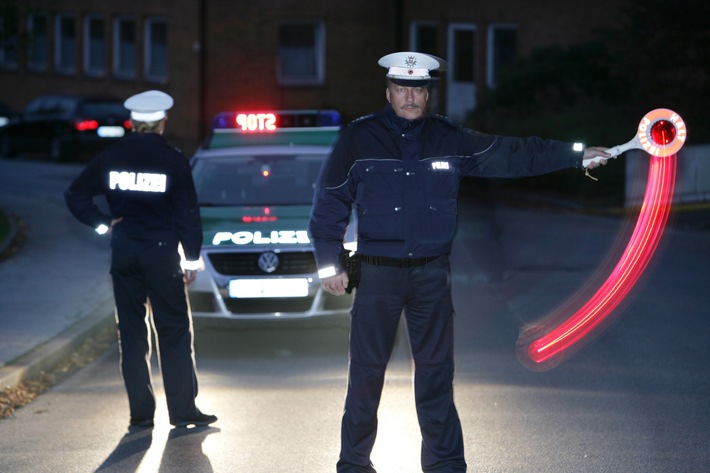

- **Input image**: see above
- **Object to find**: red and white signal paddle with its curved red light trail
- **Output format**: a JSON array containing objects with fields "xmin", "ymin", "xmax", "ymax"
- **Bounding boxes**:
[{"xmin": 517, "ymin": 108, "xmax": 686, "ymax": 371}]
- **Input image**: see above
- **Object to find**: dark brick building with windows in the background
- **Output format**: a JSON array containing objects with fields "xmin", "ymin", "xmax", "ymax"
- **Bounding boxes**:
[{"xmin": 0, "ymin": 0, "xmax": 626, "ymax": 151}]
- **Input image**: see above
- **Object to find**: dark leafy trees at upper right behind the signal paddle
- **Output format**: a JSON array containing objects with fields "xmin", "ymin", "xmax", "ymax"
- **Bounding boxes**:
[{"xmin": 467, "ymin": 0, "xmax": 710, "ymax": 204}]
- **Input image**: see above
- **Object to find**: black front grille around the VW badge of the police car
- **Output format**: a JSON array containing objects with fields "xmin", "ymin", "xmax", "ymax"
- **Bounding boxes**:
[{"xmin": 208, "ymin": 252, "xmax": 316, "ymax": 276}]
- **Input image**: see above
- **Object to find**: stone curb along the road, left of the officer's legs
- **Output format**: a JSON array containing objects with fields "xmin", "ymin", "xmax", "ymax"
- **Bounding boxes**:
[{"xmin": 0, "ymin": 299, "xmax": 116, "ymax": 390}]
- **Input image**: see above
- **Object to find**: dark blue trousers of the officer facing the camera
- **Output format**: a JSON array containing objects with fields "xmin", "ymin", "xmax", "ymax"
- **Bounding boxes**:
[{"xmin": 337, "ymin": 256, "xmax": 466, "ymax": 473}]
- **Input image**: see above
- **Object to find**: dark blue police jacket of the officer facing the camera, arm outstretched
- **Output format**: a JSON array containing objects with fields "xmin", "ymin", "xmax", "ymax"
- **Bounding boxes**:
[{"xmin": 309, "ymin": 106, "xmax": 583, "ymax": 271}]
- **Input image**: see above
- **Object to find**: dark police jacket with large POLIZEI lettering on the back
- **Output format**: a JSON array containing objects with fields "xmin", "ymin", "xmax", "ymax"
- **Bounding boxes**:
[{"xmin": 64, "ymin": 133, "xmax": 202, "ymax": 261}]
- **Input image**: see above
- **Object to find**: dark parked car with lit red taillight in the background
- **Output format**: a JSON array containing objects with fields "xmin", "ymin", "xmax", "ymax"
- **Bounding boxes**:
[{"xmin": 0, "ymin": 95, "xmax": 130, "ymax": 161}]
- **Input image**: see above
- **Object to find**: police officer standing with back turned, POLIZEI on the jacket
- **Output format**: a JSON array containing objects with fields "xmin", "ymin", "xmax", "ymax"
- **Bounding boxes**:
[{"xmin": 64, "ymin": 90, "xmax": 217, "ymax": 427}]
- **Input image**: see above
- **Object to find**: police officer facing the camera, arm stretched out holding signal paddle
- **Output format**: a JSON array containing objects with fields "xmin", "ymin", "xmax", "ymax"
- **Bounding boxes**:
[{"xmin": 309, "ymin": 52, "xmax": 609, "ymax": 472}]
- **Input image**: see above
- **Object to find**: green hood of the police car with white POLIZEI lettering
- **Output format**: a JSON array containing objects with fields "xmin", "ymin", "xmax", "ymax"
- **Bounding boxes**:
[{"xmin": 200, "ymin": 205, "xmax": 311, "ymax": 250}]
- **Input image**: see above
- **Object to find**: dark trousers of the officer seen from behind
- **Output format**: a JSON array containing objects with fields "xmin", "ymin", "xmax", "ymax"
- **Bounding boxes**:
[{"xmin": 111, "ymin": 250, "xmax": 197, "ymax": 422}]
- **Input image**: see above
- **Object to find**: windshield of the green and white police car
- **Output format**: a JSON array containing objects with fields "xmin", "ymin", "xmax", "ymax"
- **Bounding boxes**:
[{"xmin": 192, "ymin": 152, "xmax": 326, "ymax": 206}]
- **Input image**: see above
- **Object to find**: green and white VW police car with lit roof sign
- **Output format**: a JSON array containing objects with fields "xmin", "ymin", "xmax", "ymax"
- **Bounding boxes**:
[{"xmin": 188, "ymin": 110, "xmax": 354, "ymax": 322}]
